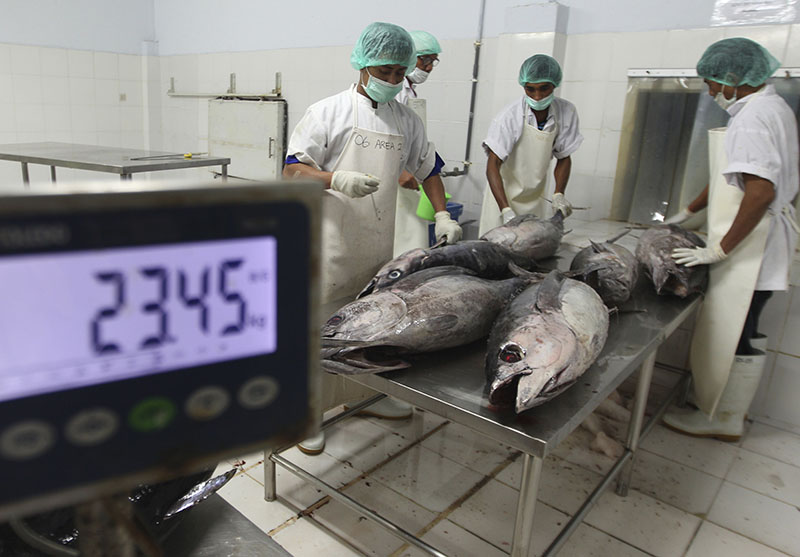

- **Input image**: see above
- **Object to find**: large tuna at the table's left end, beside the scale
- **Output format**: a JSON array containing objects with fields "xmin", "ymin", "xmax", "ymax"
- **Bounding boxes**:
[{"xmin": 322, "ymin": 267, "xmax": 531, "ymax": 374}]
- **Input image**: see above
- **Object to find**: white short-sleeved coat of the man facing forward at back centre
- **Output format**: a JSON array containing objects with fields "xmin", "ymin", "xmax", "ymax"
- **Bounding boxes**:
[{"xmin": 483, "ymin": 96, "xmax": 583, "ymax": 161}]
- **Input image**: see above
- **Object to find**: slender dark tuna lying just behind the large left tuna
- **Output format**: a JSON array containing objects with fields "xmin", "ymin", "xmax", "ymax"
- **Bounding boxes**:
[{"xmin": 356, "ymin": 240, "xmax": 534, "ymax": 298}]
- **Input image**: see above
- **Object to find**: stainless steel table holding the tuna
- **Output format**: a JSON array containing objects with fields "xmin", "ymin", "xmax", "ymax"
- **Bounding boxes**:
[{"xmin": 265, "ymin": 249, "xmax": 700, "ymax": 556}]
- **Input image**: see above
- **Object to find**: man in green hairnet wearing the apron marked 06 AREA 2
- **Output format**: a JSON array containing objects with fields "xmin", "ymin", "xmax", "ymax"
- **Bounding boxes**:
[{"xmin": 283, "ymin": 23, "xmax": 461, "ymax": 454}]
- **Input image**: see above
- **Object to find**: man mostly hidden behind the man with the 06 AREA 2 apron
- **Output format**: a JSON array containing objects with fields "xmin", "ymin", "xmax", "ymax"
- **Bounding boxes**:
[{"xmin": 394, "ymin": 31, "xmax": 442, "ymax": 256}]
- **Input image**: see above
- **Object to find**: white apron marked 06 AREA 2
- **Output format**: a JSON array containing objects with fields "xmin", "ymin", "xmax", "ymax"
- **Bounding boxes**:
[{"xmin": 321, "ymin": 91, "xmax": 404, "ymax": 411}]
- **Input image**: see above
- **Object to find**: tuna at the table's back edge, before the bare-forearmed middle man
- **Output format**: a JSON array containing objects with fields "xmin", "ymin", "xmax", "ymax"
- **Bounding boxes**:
[{"xmin": 481, "ymin": 211, "xmax": 564, "ymax": 261}]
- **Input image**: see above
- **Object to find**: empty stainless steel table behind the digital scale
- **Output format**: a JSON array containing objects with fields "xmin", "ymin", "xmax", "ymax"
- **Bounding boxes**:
[{"xmin": 0, "ymin": 142, "xmax": 231, "ymax": 186}]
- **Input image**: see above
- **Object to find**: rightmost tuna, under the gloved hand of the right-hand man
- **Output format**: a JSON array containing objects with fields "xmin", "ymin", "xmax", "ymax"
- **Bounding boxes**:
[{"xmin": 636, "ymin": 224, "xmax": 708, "ymax": 298}]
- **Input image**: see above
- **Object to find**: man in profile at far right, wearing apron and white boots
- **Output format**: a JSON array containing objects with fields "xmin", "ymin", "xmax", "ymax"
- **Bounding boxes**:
[{"xmin": 664, "ymin": 38, "xmax": 800, "ymax": 440}]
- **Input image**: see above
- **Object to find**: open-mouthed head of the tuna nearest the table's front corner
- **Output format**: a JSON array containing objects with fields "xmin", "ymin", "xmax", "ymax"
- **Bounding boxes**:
[{"xmin": 487, "ymin": 315, "xmax": 578, "ymax": 413}]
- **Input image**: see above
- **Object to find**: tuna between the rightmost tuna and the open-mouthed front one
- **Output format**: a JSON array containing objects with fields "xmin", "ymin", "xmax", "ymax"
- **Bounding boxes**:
[{"xmin": 570, "ymin": 230, "xmax": 639, "ymax": 307}]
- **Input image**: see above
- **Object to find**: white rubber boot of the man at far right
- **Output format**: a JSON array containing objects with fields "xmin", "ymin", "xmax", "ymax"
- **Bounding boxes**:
[{"xmin": 663, "ymin": 354, "xmax": 767, "ymax": 441}]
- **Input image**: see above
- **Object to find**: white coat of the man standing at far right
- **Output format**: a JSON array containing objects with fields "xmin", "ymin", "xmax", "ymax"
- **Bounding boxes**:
[{"xmin": 723, "ymin": 85, "xmax": 800, "ymax": 290}]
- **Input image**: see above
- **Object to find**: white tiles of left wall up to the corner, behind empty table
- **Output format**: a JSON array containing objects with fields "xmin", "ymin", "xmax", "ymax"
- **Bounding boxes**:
[{"xmin": 0, "ymin": 40, "xmax": 147, "ymax": 191}]
